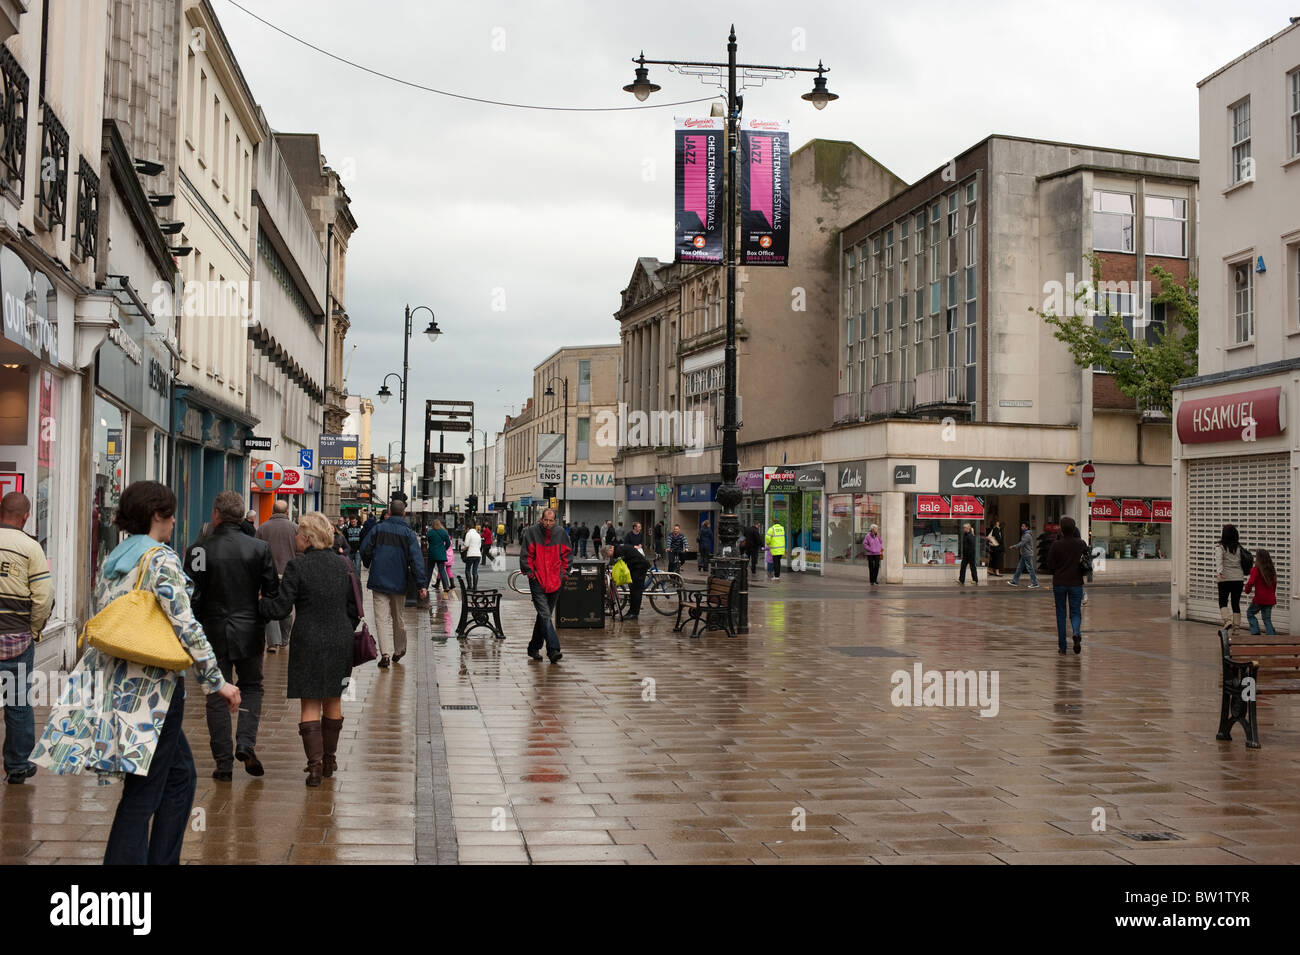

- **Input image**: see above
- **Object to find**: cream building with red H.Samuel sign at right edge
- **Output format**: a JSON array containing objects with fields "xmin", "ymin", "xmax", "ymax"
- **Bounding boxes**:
[{"xmin": 1171, "ymin": 22, "xmax": 1300, "ymax": 633}]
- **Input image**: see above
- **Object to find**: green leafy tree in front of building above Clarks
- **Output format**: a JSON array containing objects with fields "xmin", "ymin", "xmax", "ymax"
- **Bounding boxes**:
[{"xmin": 1030, "ymin": 252, "xmax": 1200, "ymax": 414}]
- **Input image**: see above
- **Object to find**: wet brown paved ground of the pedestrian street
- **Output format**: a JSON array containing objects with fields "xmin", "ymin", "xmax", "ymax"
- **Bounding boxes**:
[{"xmin": 0, "ymin": 574, "xmax": 1300, "ymax": 864}]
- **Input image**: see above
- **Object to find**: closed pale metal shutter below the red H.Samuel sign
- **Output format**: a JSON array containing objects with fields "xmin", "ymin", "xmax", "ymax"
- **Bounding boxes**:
[{"xmin": 1187, "ymin": 453, "xmax": 1291, "ymax": 633}]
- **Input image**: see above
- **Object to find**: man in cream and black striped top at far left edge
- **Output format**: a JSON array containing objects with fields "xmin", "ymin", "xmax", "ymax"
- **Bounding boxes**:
[{"xmin": 0, "ymin": 491, "xmax": 55, "ymax": 782}]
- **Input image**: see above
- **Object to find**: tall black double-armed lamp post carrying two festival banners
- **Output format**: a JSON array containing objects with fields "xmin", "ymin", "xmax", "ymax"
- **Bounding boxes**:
[{"xmin": 623, "ymin": 25, "xmax": 839, "ymax": 633}]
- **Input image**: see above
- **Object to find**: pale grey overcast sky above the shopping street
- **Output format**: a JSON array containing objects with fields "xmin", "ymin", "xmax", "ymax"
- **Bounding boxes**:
[{"xmin": 212, "ymin": 0, "xmax": 1300, "ymax": 466}]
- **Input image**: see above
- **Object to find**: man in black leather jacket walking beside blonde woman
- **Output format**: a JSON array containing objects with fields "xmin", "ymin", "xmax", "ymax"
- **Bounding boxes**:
[{"xmin": 185, "ymin": 491, "xmax": 280, "ymax": 782}]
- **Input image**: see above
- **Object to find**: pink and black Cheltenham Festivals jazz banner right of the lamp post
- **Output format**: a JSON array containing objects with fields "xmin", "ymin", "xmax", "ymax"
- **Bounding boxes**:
[{"xmin": 740, "ymin": 120, "xmax": 790, "ymax": 265}]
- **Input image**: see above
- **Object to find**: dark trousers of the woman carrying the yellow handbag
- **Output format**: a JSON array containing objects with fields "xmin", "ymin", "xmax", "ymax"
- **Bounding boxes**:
[{"xmin": 104, "ymin": 680, "xmax": 195, "ymax": 865}]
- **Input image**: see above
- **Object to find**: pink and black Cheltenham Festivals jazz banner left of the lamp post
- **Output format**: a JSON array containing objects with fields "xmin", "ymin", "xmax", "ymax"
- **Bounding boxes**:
[{"xmin": 672, "ymin": 117, "xmax": 727, "ymax": 265}]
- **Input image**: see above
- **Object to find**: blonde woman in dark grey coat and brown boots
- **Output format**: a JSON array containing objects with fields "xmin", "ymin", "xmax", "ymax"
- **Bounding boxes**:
[{"xmin": 259, "ymin": 512, "xmax": 361, "ymax": 786}]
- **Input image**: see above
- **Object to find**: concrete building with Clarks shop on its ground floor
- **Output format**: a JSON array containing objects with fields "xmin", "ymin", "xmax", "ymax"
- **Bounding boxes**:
[{"xmin": 832, "ymin": 135, "xmax": 1197, "ymax": 583}]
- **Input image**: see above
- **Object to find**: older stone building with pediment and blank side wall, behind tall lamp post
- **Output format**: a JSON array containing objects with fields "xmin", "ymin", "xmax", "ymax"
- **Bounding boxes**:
[{"xmin": 615, "ymin": 139, "xmax": 906, "ymax": 563}]
